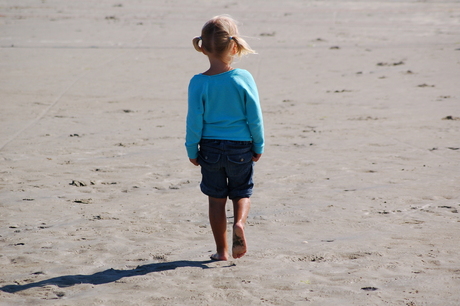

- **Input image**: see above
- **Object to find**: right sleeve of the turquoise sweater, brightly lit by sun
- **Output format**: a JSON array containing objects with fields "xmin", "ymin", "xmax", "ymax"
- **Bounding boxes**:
[{"xmin": 245, "ymin": 74, "xmax": 265, "ymax": 154}]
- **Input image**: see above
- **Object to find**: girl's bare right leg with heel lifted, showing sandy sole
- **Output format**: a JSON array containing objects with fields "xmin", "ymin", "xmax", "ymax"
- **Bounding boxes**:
[{"xmin": 232, "ymin": 198, "xmax": 251, "ymax": 258}]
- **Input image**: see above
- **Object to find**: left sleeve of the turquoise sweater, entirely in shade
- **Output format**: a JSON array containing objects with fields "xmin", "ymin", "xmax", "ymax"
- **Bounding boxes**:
[{"xmin": 185, "ymin": 78, "xmax": 204, "ymax": 158}]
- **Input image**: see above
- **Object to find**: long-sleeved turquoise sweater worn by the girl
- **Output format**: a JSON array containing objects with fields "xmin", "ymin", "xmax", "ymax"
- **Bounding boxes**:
[{"xmin": 185, "ymin": 69, "xmax": 264, "ymax": 158}]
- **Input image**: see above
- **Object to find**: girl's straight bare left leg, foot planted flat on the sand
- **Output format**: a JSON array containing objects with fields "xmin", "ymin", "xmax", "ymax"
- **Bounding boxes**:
[{"xmin": 209, "ymin": 197, "xmax": 228, "ymax": 260}]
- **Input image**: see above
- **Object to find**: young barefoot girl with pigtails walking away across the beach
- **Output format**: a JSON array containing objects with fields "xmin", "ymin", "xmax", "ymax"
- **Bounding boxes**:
[{"xmin": 185, "ymin": 16, "xmax": 264, "ymax": 260}]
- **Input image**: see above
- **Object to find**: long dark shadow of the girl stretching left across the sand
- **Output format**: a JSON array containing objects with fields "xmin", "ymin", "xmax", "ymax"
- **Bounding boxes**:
[{"xmin": 0, "ymin": 260, "xmax": 219, "ymax": 293}]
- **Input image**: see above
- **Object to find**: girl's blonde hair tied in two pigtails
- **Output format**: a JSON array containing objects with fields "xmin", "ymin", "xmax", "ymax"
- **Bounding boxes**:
[{"xmin": 192, "ymin": 15, "xmax": 256, "ymax": 58}]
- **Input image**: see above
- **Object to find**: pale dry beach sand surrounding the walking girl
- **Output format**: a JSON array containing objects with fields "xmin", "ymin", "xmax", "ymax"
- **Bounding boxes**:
[{"xmin": 0, "ymin": 0, "xmax": 460, "ymax": 306}]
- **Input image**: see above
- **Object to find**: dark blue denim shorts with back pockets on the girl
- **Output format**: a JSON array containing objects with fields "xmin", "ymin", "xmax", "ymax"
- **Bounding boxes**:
[{"xmin": 198, "ymin": 139, "xmax": 254, "ymax": 199}]
